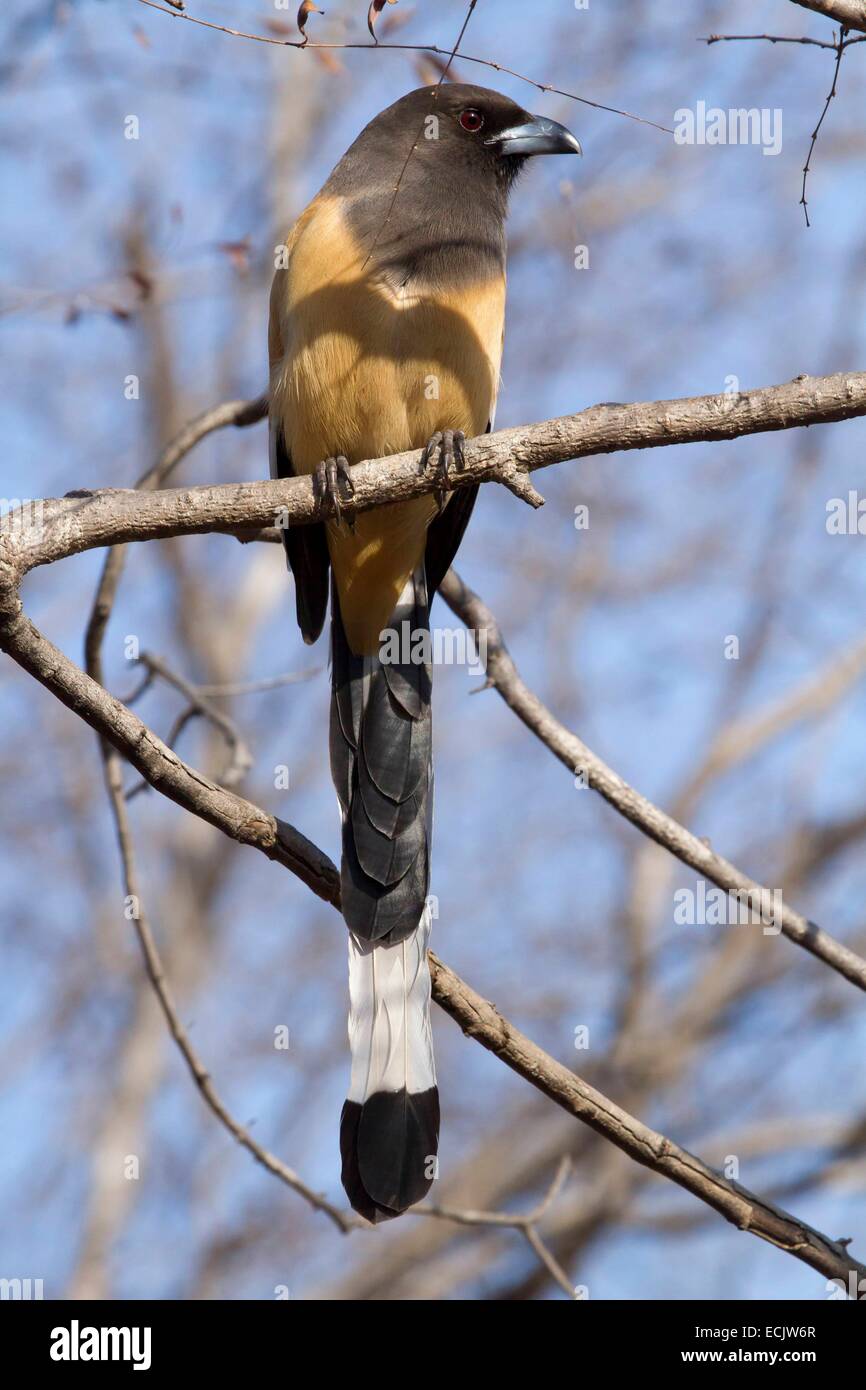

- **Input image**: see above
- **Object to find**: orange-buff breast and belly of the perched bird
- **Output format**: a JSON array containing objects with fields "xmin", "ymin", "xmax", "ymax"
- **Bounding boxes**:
[{"xmin": 271, "ymin": 199, "xmax": 505, "ymax": 653}]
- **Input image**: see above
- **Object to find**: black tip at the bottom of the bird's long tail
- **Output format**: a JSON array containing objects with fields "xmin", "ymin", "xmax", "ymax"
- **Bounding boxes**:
[{"xmin": 339, "ymin": 1086, "xmax": 439, "ymax": 1225}]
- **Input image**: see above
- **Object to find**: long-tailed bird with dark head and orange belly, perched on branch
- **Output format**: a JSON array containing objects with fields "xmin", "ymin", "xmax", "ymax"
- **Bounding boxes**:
[{"xmin": 268, "ymin": 82, "xmax": 582, "ymax": 1225}]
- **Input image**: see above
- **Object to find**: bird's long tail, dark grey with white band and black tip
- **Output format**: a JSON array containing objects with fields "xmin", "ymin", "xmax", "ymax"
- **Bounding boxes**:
[{"xmin": 331, "ymin": 566, "xmax": 439, "ymax": 1222}]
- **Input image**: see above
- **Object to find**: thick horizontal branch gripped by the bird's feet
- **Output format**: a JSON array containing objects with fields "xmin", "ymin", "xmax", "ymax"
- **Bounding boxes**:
[{"xmin": 10, "ymin": 373, "xmax": 866, "ymax": 575}]
